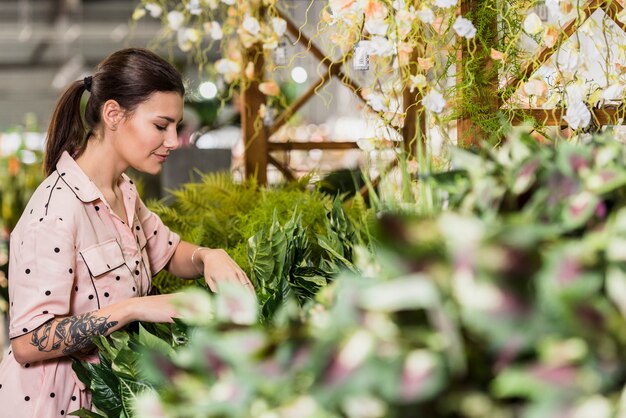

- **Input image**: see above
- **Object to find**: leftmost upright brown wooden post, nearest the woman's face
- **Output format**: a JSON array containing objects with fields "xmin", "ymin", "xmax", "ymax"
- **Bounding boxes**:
[{"xmin": 241, "ymin": 44, "xmax": 268, "ymax": 184}]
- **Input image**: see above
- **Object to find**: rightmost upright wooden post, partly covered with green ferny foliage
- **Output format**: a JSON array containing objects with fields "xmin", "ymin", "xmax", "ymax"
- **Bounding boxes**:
[{"xmin": 456, "ymin": 0, "xmax": 501, "ymax": 147}]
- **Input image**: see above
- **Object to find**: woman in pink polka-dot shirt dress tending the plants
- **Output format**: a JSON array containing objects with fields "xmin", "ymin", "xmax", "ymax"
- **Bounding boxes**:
[{"xmin": 0, "ymin": 49, "xmax": 252, "ymax": 418}]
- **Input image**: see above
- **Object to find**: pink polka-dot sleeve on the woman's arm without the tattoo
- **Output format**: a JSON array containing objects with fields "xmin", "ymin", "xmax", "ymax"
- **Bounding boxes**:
[{"xmin": 137, "ymin": 198, "xmax": 180, "ymax": 274}]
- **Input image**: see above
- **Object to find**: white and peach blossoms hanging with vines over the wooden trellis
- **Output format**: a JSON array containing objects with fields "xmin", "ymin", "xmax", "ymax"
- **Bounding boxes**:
[{"xmin": 133, "ymin": 0, "xmax": 626, "ymax": 147}]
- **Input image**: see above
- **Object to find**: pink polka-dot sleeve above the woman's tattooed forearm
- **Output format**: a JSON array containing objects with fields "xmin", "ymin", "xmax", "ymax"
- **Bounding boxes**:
[{"xmin": 9, "ymin": 217, "xmax": 76, "ymax": 338}]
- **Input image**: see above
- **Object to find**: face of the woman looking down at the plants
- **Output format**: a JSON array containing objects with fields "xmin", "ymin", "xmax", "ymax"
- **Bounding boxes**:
[{"xmin": 115, "ymin": 92, "xmax": 183, "ymax": 174}]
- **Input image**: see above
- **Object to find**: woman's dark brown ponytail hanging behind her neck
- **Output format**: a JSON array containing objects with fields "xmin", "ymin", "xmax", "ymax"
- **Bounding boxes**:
[{"xmin": 43, "ymin": 80, "xmax": 87, "ymax": 176}]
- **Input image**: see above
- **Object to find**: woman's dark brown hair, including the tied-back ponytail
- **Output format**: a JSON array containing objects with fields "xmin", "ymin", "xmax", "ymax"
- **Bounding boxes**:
[{"xmin": 44, "ymin": 48, "xmax": 185, "ymax": 176}]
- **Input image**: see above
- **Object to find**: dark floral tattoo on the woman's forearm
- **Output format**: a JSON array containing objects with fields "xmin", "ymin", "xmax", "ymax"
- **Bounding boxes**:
[{"xmin": 31, "ymin": 313, "xmax": 117, "ymax": 354}]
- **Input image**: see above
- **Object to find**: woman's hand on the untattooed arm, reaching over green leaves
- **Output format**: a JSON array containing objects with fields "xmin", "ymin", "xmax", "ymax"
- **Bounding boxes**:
[{"xmin": 198, "ymin": 248, "xmax": 255, "ymax": 294}]
